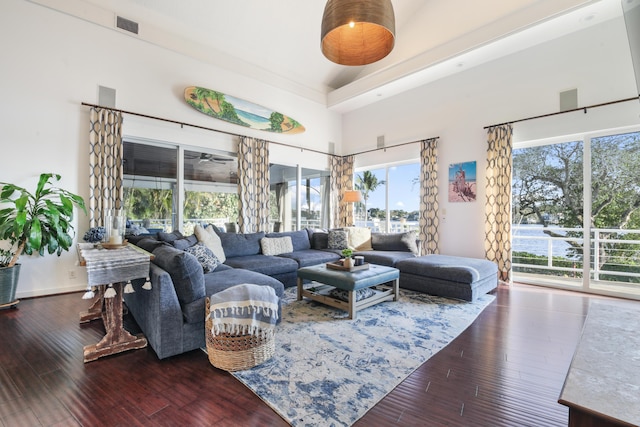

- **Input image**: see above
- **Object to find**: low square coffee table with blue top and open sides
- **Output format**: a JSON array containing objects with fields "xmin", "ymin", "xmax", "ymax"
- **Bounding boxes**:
[{"xmin": 298, "ymin": 264, "xmax": 400, "ymax": 319}]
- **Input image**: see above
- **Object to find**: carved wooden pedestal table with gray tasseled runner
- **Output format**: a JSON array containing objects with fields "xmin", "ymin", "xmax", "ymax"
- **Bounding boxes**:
[{"xmin": 78, "ymin": 243, "xmax": 153, "ymax": 363}]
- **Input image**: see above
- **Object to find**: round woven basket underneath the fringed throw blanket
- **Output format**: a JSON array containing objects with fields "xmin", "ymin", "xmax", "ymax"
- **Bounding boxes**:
[{"xmin": 205, "ymin": 298, "xmax": 276, "ymax": 371}]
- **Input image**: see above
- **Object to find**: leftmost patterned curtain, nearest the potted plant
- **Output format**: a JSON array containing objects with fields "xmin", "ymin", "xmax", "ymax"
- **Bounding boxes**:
[{"xmin": 89, "ymin": 108, "xmax": 124, "ymax": 227}]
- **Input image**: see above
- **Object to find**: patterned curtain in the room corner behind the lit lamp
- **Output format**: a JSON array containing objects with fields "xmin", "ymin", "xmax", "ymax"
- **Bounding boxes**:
[{"xmin": 330, "ymin": 156, "xmax": 355, "ymax": 228}]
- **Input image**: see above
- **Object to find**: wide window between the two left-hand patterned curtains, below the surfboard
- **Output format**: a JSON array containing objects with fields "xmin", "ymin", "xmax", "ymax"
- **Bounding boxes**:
[{"xmin": 124, "ymin": 141, "xmax": 238, "ymax": 234}]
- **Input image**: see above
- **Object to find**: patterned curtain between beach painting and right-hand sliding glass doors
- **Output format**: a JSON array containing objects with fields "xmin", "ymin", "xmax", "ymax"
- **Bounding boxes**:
[{"xmin": 484, "ymin": 124, "xmax": 513, "ymax": 281}]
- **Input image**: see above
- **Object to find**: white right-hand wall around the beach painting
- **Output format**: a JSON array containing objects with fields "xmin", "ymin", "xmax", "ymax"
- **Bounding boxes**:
[{"xmin": 342, "ymin": 18, "xmax": 640, "ymax": 257}]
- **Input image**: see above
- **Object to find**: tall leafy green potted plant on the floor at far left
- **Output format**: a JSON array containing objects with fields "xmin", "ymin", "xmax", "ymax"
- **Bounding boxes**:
[{"xmin": 0, "ymin": 173, "xmax": 87, "ymax": 306}]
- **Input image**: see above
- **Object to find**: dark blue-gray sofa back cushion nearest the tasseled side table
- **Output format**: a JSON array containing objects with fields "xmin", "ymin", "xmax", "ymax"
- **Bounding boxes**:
[{"xmin": 153, "ymin": 245, "xmax": 205, "ymax": 306}]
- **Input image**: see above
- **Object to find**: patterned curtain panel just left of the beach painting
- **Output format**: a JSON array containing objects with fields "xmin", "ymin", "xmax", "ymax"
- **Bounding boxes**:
[{"xmin": 420, "ymin": 138, "xmax": 440, "ymax": 255}]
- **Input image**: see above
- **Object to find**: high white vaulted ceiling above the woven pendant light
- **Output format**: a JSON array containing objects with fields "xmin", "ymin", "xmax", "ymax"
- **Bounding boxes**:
[{"xmin": 30, "ymin": 0, "xmax": 621, "ymax": 112}]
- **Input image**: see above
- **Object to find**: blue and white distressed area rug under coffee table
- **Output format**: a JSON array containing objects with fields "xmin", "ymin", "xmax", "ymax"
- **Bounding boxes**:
[{"xmin": 233, "ymin": 288, "xmax": 495, "ymax": 426}]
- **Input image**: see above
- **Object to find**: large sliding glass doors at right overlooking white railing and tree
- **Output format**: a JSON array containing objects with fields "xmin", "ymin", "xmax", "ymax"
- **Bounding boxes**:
[{"xmin": 512, "ymin": 132, "xmax": 640, "ymax": 297}]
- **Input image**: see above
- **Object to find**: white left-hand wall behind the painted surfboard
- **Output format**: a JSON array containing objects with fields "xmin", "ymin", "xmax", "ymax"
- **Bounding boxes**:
[{"xmin": 0, "ymin": 0, "xmax": 341, "ymax": 298}]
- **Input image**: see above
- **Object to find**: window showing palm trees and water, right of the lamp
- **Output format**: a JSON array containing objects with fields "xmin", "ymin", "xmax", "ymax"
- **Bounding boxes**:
[{"xmin": 354, "ymin": 163, "xmax": 420, "ymax": 232}]
